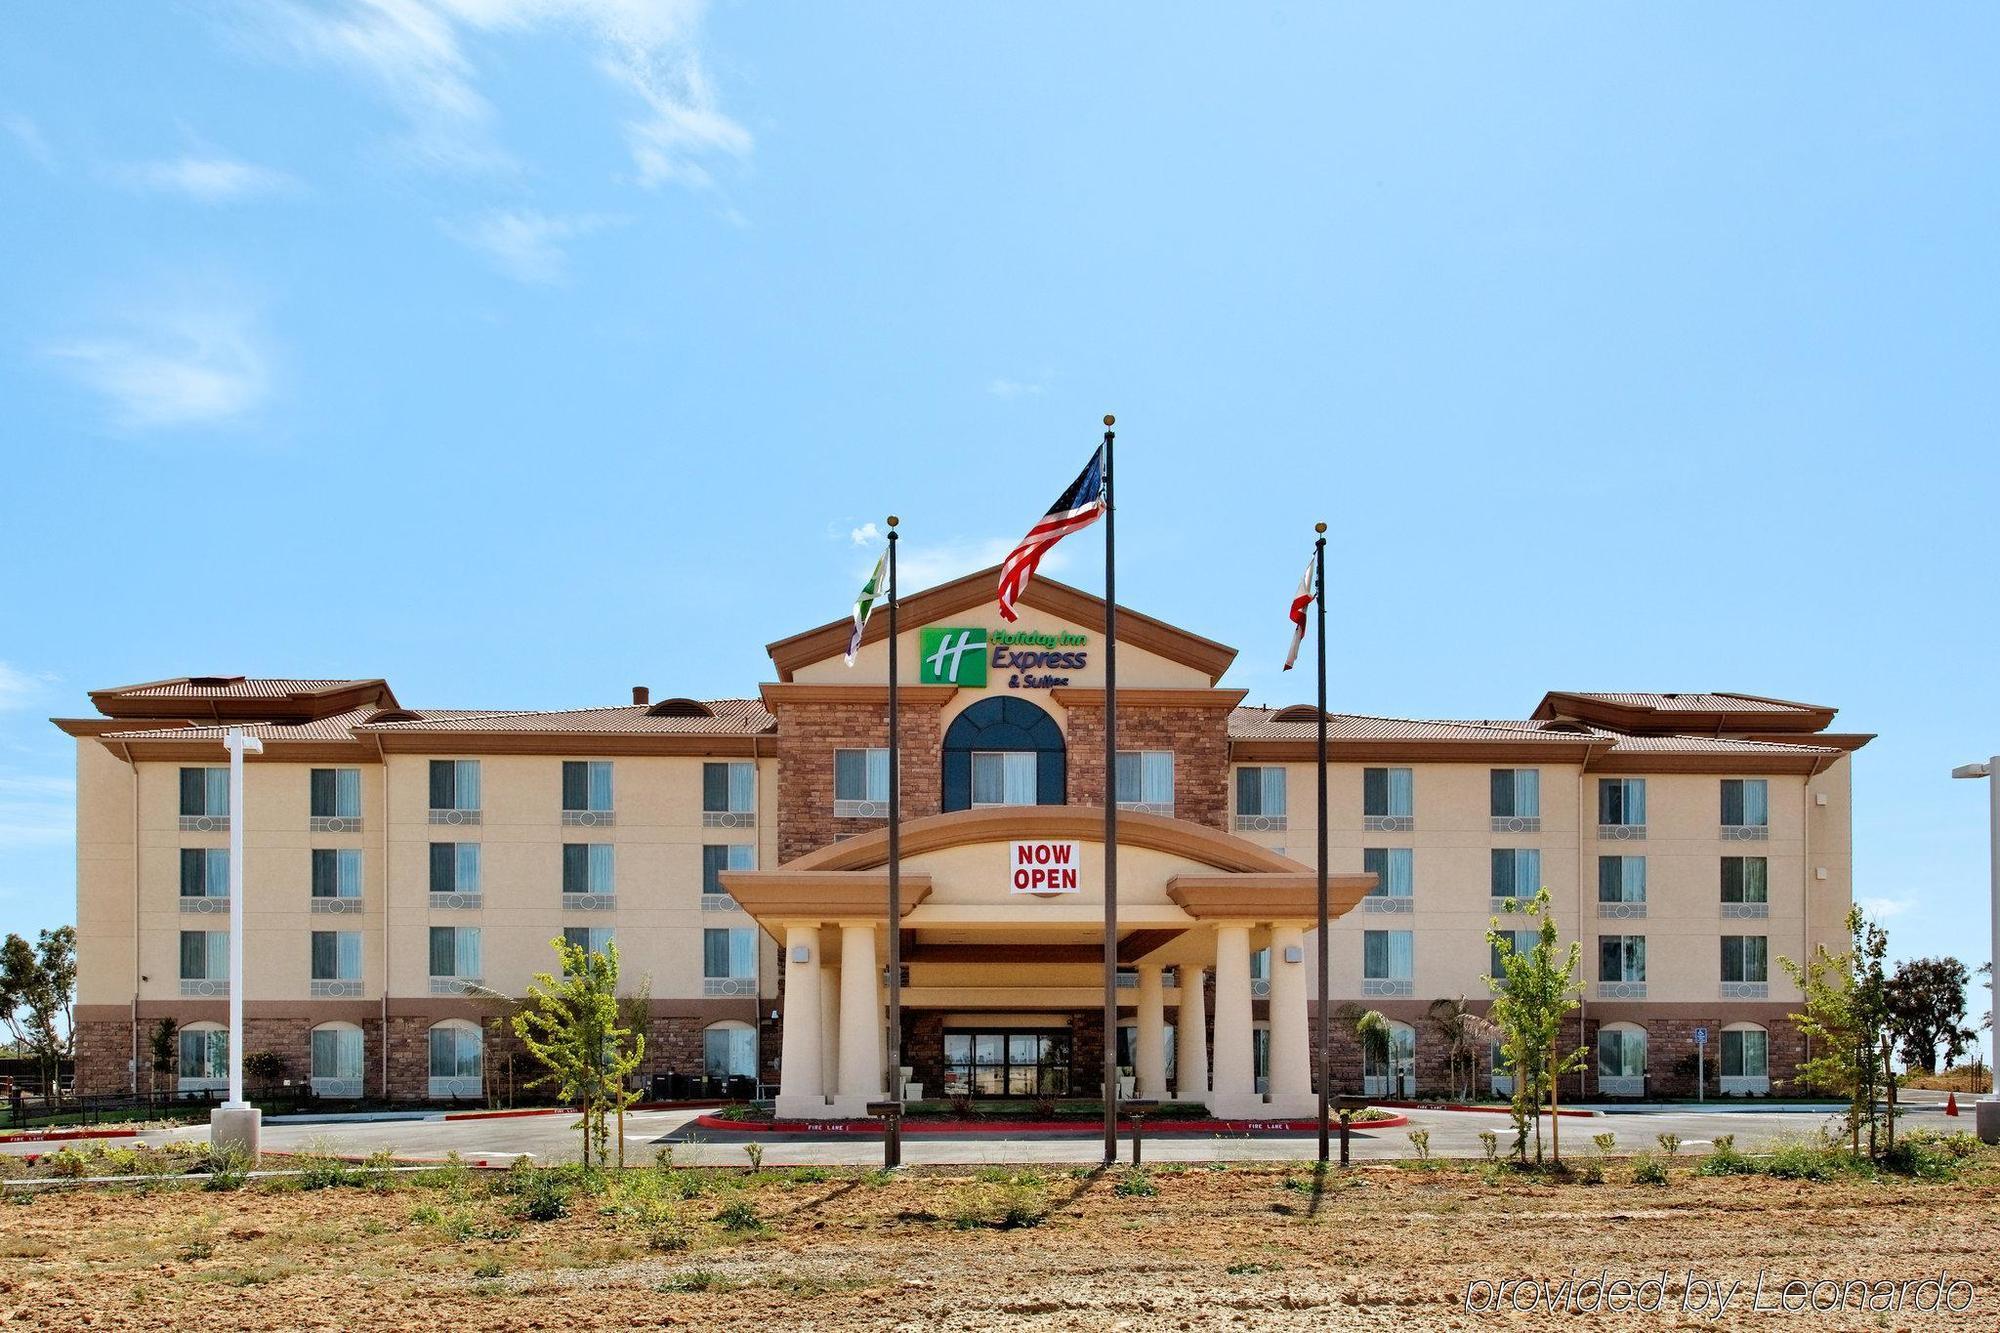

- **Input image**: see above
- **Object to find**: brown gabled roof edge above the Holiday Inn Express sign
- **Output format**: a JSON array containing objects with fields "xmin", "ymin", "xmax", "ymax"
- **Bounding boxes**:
[{"xmin": 766, "ymin": 564, "xmax": 1236, "ymax": 685}]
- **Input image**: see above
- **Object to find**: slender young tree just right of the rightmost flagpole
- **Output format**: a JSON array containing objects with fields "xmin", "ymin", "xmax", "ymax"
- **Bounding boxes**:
[{"xmin": 1486, "ymin": 889, "xmax": 1584, "ymax": 1165}]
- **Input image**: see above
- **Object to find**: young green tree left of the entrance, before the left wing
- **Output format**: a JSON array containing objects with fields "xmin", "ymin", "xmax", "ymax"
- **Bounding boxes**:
[{"xmin": 514, "ymin": 939, "xmax": 646, "ymax": 1167}]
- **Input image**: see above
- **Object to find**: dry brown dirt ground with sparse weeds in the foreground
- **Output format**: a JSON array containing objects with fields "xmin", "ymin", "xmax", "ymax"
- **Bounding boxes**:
[{"xmin": 0, "ymin": 1163, "xmax": 2000, "ymax": 1331}]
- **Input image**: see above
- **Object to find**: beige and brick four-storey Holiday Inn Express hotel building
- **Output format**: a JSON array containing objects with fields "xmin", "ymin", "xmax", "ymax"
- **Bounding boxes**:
[{"xmin": 56, "ymin": 570, "xmax": 1870, "ymax": 1119}]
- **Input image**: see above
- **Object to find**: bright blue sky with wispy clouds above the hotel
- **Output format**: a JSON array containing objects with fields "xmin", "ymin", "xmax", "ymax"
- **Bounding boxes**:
[{"xmin": 0, "ymin": 0, "xmax": 2000, "ymax": 984}]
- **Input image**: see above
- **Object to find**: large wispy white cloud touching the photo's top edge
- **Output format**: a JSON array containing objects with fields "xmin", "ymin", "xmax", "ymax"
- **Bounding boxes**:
[{"xmin": 240, "ymin": 0, "xmax": 752, "ymax": 188}]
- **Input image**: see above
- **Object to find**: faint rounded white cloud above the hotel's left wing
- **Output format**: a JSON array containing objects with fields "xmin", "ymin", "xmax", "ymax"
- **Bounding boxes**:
[{"xmin": 42, "ymin": 292, "xmax": 272, "ymax": 430}]
